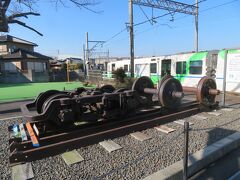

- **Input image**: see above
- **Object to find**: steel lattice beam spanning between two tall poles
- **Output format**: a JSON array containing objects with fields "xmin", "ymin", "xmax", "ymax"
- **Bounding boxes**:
[{"xmin": 132, "ymin": 0, "xmax": 196, "ymax": 15}]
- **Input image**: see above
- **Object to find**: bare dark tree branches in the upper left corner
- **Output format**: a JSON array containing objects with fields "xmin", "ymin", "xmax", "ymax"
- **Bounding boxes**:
[{"xmin": 0, "ymin": 0, "xmax": 98, "ymax": 36}]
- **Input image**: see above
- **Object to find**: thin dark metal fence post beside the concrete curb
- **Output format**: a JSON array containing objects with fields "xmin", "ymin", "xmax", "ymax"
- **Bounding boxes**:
[{"xmin": 183, "ymin": 121, "xmax": 189, "ymax": 180}]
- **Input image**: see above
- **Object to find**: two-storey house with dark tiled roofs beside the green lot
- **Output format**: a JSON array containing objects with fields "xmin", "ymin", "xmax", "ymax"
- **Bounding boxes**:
[{"xmin": 0, "ymin": 35, "xmax": 51, "ymax": 83}]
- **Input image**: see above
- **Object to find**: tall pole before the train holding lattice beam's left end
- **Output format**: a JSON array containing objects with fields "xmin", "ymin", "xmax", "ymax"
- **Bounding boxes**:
[{"xmin": 129, "ymin": 0, "xmax": 134, "ymax": 77}]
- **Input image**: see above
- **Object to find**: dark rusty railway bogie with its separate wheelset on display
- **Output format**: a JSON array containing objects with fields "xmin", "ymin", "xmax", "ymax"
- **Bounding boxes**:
[{"xmin": 21, "ymin": 75, "xmax": 219, "ymax": 126}]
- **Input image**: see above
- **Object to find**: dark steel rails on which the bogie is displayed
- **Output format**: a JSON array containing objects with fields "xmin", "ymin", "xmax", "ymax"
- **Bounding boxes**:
[{"xmin": 9, "ymin": 102, "xmax": 202, "ymax": 166}]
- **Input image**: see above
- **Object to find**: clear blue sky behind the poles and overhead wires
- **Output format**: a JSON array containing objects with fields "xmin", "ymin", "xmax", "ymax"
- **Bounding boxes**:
[{"xmin": 5, "ymin": 0, "xmax": 240, "ymax": 56}]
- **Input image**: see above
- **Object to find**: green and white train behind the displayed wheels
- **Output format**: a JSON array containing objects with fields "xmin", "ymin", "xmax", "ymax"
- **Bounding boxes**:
[{"xmin": 105, "ymin": 49, "xmax": 240, "ymax": 93}]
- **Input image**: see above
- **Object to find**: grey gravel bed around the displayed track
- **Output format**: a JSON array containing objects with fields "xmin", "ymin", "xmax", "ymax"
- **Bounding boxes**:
[{"xmin": 0, "ymin": 109, "xmax": 240, "ymax": 180}]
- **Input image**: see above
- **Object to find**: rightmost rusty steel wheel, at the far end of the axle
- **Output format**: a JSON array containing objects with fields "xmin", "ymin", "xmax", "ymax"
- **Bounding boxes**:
[{"xmin": 196, "ymin": 76, "xmax": 217, "ymax": 106}]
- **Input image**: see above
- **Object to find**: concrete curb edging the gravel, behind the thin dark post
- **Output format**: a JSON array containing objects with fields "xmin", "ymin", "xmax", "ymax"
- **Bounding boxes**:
[{"xmin": 144, "ymin": 132, "xmax": 240, "ymax": 180}]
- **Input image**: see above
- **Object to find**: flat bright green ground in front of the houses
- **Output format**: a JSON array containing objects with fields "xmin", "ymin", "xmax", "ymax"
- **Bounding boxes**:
[{"xmin": 0, "ymin": 82, "xmax": 94, "ymax": 102}]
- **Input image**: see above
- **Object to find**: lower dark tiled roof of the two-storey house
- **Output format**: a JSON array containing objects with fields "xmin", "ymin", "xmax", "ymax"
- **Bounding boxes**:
[{"xmin": 2, "ymin": 49, "xmax": 52, "ymax": 60}]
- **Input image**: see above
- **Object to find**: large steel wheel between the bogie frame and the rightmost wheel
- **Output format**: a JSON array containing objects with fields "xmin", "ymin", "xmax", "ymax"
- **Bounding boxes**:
[{"xmin": 158, "ymin": 76, "xmax": 183, "ymax": 109}]
